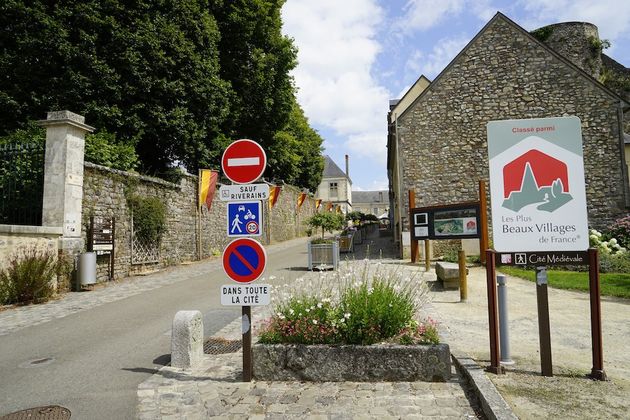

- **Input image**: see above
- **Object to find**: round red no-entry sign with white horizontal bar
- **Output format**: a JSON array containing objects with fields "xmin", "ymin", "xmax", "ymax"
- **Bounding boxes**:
[{"xmin": 221, "ymin": 139, "xmax": 267, "ymax": 184}]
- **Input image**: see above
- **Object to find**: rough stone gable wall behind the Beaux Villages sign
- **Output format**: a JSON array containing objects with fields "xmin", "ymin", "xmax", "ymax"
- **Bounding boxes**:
[{"xmin": 398, "ymin": 17, "xmax": 627, "ymax": 231}]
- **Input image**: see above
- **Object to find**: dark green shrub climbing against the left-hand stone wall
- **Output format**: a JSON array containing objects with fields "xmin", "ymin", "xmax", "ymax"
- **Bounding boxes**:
[{"xmin": 127, "ymin": 195, "xmax": 166, "ymax": 243}]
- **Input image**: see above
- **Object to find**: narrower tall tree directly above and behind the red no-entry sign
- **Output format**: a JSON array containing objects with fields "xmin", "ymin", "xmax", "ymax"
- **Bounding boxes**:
[{"xmin": 211, "ymin": 0, "xmax": 299, "ymax": 174}]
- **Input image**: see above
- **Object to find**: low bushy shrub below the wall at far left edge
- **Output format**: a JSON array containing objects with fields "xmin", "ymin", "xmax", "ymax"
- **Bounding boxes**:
[{"xmin": 0, "ymin": 247, "xmax": 58, "ymax": 305}]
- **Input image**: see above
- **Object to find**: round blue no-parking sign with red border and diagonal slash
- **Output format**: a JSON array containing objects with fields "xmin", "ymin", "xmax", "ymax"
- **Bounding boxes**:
[{"xmin": 223, "ymin": 238, "xmax": 267, "ymax": 283}]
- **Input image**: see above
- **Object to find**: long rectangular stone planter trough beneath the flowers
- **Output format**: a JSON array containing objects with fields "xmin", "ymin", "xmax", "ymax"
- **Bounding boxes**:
[{"xmin": 252, "ymin": 344, "xmax": 451, "ymax": 382}]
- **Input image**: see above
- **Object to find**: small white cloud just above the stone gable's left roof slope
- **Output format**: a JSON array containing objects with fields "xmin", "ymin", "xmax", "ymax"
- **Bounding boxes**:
[{"xmin": 405, "ymin": 36, "xmax": 470, "ymax": 80}]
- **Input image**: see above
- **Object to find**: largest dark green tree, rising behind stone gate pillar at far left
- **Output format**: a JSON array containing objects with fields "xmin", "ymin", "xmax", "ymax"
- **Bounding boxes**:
[{"xmin": 0, "ymin": 0, "xmax": 230, "ymax": 174}]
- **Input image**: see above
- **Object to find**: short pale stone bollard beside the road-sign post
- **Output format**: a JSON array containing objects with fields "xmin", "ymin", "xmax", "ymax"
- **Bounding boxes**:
[{"xmin": 171, "ymin": 311, "xmax": 203, "ymax": 369}]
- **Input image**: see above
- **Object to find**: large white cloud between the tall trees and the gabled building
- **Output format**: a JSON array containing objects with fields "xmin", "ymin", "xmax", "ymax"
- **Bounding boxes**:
[{"xmin": 282, "ymin": 0, "xmax": 391, "ymax": 169}]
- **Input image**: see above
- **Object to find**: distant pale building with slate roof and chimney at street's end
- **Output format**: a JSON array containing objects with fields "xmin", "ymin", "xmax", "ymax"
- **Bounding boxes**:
[{"xmin": 315, "ymin": 155, "xmax": 352, "ymax": 214}]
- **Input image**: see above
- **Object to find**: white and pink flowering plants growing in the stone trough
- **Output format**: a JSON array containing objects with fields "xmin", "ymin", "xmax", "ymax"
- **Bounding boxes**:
[{"xmin": 258, "ymin": 263, "xmax": 439, "ymax": 345}]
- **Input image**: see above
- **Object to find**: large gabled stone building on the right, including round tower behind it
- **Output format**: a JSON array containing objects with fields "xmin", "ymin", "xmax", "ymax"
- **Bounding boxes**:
[{"xmin": 388, "ymin": 13, "xmax": 630, "ymax": 253}]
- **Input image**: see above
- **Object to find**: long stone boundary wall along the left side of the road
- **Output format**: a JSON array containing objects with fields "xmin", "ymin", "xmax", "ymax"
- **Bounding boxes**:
[{"xmin": 82, "ymin": 163, "xmax": 315, "ymax": 282}]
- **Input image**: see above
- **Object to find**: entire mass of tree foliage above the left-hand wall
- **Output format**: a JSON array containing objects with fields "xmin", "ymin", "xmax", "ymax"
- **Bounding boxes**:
[{"xmin": 0, "ymin": 0, "xmax": 321, "ymax": 190}]
